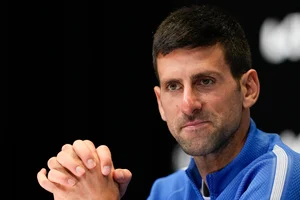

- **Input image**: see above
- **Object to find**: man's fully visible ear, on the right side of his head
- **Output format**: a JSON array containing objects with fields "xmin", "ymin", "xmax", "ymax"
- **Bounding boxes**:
[{"xmin": 240, "ymin": 69, "xmax": 260, "ymax": 108}]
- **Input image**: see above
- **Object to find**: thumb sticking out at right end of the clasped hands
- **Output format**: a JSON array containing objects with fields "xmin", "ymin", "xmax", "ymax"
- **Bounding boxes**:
[{"xmin": 113, "ymin": 169, "xmax": 132, "ymax": 197}]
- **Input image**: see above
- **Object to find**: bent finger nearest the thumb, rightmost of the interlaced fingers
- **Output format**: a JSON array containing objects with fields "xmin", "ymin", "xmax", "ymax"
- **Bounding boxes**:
[{"xmin": 97, "ymin": 145, "xmax": 113, "ymax": 176}]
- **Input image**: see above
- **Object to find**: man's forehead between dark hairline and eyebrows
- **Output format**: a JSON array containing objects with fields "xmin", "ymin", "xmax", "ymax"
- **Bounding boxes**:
[{"xmin": 157, "ymin": 44, "xmax": 231, "ymax": 81}]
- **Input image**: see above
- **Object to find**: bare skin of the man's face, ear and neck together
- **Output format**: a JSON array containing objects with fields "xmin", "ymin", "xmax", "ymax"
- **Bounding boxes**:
[{"xmin": 154, "ymin": 44, "xmax": 259, "ymax": 181}]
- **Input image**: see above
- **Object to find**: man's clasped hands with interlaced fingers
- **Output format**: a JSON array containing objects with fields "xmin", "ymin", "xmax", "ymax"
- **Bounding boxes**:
[{"xmin": 37, "ymin": 140, "xmax": 132, "ymax": 200}]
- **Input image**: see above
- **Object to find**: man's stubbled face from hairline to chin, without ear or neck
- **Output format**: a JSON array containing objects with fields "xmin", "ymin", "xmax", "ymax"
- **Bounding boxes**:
[{"xmin": 154, "ymin": 45, "xmax": 243, "ymax": 156}]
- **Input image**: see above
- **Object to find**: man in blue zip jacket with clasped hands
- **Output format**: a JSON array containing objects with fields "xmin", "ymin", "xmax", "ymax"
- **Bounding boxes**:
[{"xmin": 38, "ymin": 5, "xmax": 300, "ymax": 200}]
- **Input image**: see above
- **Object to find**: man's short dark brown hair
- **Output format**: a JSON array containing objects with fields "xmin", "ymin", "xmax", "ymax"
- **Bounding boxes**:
[{"xmin": 152, "ymin": 5, "xmax": 252, "ymax": 80}]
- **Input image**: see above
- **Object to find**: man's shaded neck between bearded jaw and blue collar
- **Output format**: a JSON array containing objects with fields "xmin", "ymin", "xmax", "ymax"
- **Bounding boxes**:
[{"xmin": 194, "ymin": 113, "xmax": 250, "ymax": 183}]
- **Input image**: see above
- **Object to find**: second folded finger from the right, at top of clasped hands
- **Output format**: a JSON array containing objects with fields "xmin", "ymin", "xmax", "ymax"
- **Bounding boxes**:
[{"xmin": 73, "ymin": 140, "xmax": 96, "ymax": 169}]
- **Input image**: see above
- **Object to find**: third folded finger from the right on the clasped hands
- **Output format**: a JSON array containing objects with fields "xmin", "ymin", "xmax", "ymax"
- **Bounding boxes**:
[{"xmin": 56, "ymin": 149, "xmax": 86, "ymax": 177}]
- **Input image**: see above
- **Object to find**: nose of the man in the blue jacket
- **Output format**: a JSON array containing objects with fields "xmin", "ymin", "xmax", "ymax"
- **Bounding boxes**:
[{"xmin": 181, "ymin": 88, "xmax": 202, "ymax": 116}]
